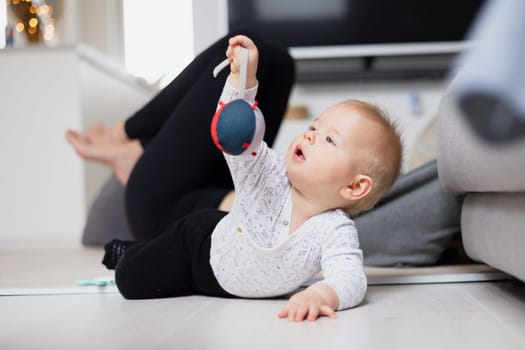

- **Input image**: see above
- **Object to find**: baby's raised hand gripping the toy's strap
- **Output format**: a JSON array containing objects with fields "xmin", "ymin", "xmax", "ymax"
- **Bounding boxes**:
[{"xmin": 226, "ymin": 35, "xmax": 259, "ymax": 89}]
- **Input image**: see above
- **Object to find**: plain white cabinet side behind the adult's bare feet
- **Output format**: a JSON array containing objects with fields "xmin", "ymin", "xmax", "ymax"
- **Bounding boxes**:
[{"xmin": 0, "ymin": 49, "xmax": 85, "ymax": 243}]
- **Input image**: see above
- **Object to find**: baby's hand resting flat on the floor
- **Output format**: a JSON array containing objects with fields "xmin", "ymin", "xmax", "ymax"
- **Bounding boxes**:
[{"xmin": 279, "ymin": 287, "xmax": 335, "ymax": 322}]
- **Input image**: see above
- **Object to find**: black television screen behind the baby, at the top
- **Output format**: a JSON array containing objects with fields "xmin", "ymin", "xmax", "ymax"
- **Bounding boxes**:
[{"xmin": 227, "ymin": 0, "xmax": 483, "ymax": 58}]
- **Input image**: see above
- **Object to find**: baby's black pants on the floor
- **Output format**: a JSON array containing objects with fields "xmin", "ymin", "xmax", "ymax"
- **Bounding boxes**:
[{"xmin": 115, "ymin": 209, "xmax": 232, "ymax": 299}]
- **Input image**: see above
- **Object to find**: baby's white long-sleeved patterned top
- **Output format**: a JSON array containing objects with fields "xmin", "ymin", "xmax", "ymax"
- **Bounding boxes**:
[{"xmin": 210, "ymin": 83, "xmax": 367, "ymax": 310}]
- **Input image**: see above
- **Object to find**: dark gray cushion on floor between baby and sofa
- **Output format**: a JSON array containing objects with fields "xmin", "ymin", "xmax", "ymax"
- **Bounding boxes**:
[{"xmin": 355, "ymin": 160, "xmax": 462, "ymax": 266}]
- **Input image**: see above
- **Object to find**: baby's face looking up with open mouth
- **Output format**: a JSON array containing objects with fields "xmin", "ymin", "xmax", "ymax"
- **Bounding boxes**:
[{"xmin": 286, "ymin": 105, "xmax": 377, "ymax": 200}]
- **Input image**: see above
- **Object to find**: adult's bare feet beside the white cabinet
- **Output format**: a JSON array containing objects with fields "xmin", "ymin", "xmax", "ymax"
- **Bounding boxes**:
[{"xmin": 65, "ymin": 121, "xmax": 143, "ymax": 185}]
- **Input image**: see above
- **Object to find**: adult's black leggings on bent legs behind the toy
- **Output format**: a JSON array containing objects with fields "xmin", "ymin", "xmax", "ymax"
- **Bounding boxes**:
[{"xmin": 125, "ymin": 34, "xmax": 295, "ymax": 240}]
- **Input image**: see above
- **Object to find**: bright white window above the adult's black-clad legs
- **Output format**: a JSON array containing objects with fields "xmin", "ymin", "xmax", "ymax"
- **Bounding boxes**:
[{"xmin": 123, "ymin": 0, "xmax": 193, "ymax": 87}]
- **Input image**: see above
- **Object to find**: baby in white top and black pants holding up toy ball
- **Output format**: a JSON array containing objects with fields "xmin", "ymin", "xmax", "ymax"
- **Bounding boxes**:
[{"xmin": 105, "ymin": 35, "xmax": 402, "ymax": 321}]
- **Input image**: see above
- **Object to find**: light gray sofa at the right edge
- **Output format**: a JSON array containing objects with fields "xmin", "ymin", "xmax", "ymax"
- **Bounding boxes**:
[{"xmin": 437, "ymin": 95, "xmax": 525, "ymax": 281}]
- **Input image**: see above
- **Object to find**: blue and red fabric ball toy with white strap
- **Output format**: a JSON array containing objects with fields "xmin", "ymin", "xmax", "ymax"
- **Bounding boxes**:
[{"xmin": 210, "ymin": 47, "xmax": 265, "ymax": 156}]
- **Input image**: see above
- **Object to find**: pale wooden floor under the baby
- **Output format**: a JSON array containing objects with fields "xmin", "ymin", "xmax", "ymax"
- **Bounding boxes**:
[{"xmin": 0, "ymin": 242, "xmax": 525, "ymax": 350}]
